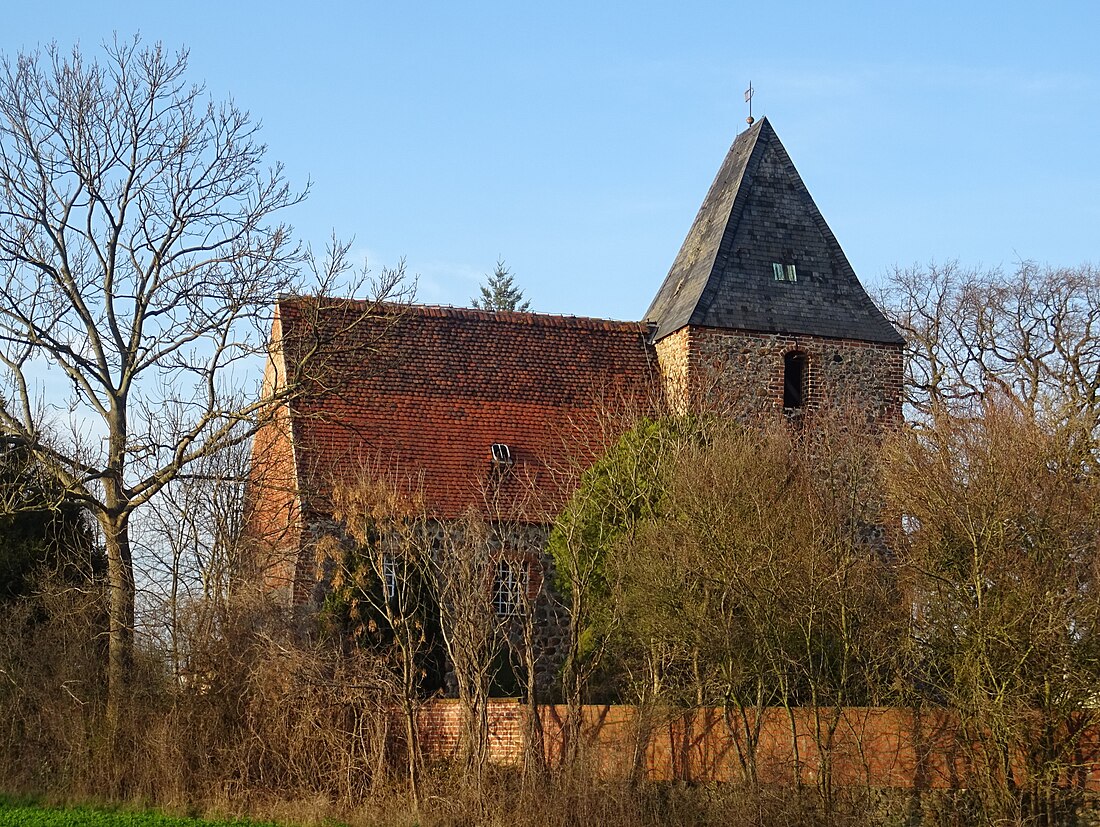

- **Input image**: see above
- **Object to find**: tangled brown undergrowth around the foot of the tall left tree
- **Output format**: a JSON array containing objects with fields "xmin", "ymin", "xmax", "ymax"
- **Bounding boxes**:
[{"xmin": 0, "ymin": 592, "xmax": 406, "ymax": 804}]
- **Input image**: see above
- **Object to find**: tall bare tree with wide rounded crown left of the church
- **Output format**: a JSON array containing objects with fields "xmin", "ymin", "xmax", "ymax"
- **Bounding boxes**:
[{"xmin": 0, "ymin": 38, "xmax": 407, "ymax": 714}]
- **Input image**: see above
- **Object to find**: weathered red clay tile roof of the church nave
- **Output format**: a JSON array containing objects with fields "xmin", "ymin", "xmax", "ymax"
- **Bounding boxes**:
[{"xmin": 278, "ymin": 299, "xmax": 659, "ymax": 521}]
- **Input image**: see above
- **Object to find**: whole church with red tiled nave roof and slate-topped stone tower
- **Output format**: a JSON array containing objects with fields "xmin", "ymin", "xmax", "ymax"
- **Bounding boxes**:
[{"xmin": 252, "ymin": 118, "xmax": 903, "ymax": 607}]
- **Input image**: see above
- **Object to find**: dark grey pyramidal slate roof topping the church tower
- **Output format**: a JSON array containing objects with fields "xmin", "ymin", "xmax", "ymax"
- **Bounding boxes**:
[{"xmin": 646, "ymin": 118, "xmax": 902, "ymax": 344}]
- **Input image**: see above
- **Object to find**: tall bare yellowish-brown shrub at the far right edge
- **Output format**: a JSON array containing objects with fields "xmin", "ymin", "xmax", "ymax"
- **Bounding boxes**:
[{"xmin": 888, "ymin": 401, "xmax": 1100, "ymax": 824}]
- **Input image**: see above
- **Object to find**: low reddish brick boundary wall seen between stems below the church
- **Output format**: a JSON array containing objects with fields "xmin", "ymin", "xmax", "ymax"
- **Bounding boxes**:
[{"xmin": 419, "ymin": 699, "xmax": 1100, "ymax": 791}]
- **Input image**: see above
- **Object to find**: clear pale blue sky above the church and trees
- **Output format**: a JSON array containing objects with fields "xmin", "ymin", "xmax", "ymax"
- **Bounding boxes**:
[{"xmin": 0, "ymin": 0, "xmax": 1100, "ymax": 319}]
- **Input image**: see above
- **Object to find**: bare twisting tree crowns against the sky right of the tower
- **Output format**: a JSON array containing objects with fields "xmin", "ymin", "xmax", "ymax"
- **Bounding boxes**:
[{"xmin": 882, "ymin": 262, "xmax": 1100, "ymax": 429}]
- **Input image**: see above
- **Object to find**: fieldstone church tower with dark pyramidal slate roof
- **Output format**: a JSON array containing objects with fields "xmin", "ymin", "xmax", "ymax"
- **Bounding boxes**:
[{"xmin": 646, "ymin": 118, "xmax": 904, "ymax": 423}]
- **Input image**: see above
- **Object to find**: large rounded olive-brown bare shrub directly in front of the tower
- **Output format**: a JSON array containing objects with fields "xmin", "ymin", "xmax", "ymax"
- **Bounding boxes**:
[{"xmin": 609, "ymin": 409, "xmax": 908, "ymax": 812}]
